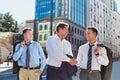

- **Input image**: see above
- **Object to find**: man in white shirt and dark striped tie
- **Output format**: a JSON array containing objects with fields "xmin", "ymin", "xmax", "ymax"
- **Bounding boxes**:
[{"xmin": 77, "ymin": 27, "xmax": 109, "ymax": 80}]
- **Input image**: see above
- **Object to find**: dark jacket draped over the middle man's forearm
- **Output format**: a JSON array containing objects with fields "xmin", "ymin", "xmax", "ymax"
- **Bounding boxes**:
[{"xmin": 58, "ymin": 55, "xmax": 77, "ymax": 80}]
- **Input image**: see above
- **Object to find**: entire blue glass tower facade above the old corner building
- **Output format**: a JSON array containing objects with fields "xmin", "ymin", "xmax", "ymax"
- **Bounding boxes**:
[{"xmin": 36, "ymin": 0, "xmax": 86, "ymax": 27}]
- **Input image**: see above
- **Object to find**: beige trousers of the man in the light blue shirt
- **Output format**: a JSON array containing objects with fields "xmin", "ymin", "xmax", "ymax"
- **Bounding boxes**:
[{"xmin": 19, "ymin": 68, "xmax": 40, "ymax": 80}]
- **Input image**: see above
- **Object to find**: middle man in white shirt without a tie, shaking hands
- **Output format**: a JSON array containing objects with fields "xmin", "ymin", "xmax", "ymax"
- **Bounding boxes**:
[{"xmin": 46, "ymin": 22, "xmax": 76, "ymax": 80}]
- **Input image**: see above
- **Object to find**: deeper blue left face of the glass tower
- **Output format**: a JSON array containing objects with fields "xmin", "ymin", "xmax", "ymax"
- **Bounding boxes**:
[{"xmin": 35, "ymin": 0, "xmax": 55, "ymax": 20}]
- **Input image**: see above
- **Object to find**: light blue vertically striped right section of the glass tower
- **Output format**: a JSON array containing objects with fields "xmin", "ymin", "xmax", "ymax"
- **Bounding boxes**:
[{"xmin": 71, "ymin": 0, "xmax": 86, "ymax": 27}]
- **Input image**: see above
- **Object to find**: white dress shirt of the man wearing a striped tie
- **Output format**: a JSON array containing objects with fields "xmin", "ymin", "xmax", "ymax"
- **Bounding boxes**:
[{"xmin": 77, "ymin": 42, "xmax": 109, "ymax": 71}]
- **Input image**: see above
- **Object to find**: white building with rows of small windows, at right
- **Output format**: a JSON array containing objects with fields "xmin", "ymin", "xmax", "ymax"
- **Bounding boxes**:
[{"xmin": 87, "ymin": 0, "xmax": 118, "ymax": 57}]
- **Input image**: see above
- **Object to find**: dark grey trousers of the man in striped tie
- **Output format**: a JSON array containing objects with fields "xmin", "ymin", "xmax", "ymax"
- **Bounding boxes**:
[{"xmin": 80, "ymin": 71, "xmax": 101, "ymax": 80}]
